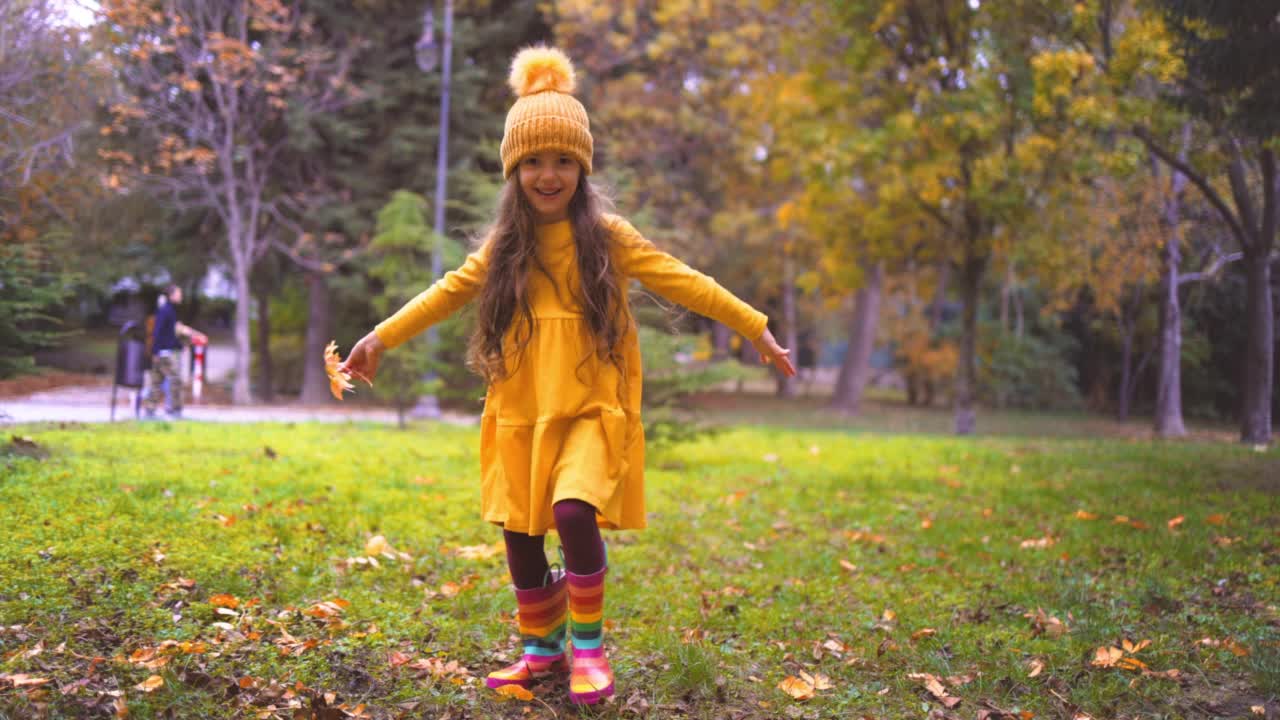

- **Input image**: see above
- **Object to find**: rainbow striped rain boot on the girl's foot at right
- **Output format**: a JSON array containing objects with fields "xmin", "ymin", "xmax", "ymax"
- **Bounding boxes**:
[{"xmin": 564, "ymin": 568, "xmax": 613, "ymax": 705}]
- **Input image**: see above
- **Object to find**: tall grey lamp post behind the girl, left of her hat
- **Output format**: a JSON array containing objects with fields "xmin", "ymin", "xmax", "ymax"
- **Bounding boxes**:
[{"xmin": 410, "ymin": 0, "xmax": 453, "ymax": 418}]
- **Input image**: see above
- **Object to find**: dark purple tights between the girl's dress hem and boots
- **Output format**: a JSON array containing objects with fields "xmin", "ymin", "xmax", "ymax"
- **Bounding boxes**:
[{"xmin": 502, "ymin": 500, "xmax": 604, "ymax": 589}]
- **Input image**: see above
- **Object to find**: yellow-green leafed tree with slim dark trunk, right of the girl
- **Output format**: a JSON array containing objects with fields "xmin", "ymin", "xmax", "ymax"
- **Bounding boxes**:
[{"xmin": 855, "ymin": 0, "xmax": 1092, "ymax": 434}]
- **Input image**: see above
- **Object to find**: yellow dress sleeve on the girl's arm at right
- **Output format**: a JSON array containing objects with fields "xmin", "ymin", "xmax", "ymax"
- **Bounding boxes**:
[{"xmin": 609, "ymin": 217, "xmax": 768, "ymax": 340}]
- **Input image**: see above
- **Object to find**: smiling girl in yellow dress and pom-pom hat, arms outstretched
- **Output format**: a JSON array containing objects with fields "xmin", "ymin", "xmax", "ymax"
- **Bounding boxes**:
[{"xmin": 342, "ymin": 47, "xmax": 795, "ymax": 703}]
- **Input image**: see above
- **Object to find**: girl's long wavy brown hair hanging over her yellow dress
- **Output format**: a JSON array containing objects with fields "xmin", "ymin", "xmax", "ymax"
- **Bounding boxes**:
[{"xmin": 467, "ymin": 173, "xmax": 630, "ymax": 383}]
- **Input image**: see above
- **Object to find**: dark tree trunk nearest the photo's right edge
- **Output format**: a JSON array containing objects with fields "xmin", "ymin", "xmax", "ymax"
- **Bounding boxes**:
[{"xmin": 1240, "ymin": 252, "xmax": 1275, "ymax": 445}]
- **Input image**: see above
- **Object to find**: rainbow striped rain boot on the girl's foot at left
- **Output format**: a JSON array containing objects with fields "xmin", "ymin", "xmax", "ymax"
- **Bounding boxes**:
[{"xmin": 485, "ymin": 573, "xmax": 568, "ymax": 689}]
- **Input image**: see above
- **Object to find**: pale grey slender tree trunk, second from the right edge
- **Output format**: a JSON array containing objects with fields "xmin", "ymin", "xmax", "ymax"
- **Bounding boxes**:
[{"xmin": 1153, "ymin": 148, "xmax": 1187, "ymax": 437}]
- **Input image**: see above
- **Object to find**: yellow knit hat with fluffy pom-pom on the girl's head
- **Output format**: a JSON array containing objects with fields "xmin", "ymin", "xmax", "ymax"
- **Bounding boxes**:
[{"xmin": 500, "ymin": 46, "xmax": 594, "ymax": 177}]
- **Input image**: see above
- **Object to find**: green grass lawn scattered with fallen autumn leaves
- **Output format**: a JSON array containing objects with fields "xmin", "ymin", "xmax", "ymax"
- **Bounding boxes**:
[{"xmin": 0, "ymin": 424, "xmax": 1280, "ymax": 719}]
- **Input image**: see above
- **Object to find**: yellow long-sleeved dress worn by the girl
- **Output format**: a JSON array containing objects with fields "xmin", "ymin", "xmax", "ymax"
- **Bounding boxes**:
[{"xmin": 375, "ymin": 215, "xmax": 767, "ymax": 536}]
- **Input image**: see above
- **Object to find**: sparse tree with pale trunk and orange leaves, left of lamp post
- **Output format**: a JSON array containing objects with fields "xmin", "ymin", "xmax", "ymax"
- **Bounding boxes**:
[{"xmin": 101, "ymin": 0, "xmax": 352, "ymax": 404}]
